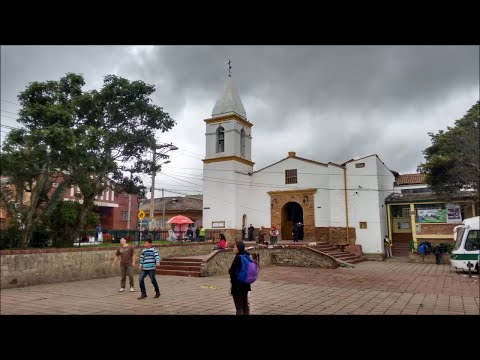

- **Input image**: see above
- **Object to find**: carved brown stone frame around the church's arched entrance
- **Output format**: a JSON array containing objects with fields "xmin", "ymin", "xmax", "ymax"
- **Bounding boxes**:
[{"xmin": 268, "ymin": 188, "xmax": 317, "ymax": 240}]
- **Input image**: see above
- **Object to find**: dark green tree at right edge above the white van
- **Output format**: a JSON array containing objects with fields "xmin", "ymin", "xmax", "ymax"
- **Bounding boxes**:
[{"xmin": 418, "ymin": 102, "xmax": 480, "ymax": 199}]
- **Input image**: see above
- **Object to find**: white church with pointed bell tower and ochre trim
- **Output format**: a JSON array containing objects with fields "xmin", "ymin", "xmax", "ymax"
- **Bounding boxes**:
[{"xmin": 203, "ymin": 76, "xmax": 395, "ymax": 257}]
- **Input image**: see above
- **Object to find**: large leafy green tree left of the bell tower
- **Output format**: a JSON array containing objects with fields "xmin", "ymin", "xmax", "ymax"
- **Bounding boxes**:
[{"xmin": 2, "ymin": 73, "xmax": 175, "ymax": 245}]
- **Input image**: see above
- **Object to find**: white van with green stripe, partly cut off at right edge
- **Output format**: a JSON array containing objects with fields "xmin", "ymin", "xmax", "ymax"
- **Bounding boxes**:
[{"xmin": 450, "ymin": 216, "xmax": 480, "ymax": 272}]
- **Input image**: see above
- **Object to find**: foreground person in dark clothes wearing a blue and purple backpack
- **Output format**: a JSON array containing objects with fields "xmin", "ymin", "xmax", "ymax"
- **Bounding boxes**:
[{"xmin": 228, "ymin": 241, "xmax": 258, "ymax": 315}]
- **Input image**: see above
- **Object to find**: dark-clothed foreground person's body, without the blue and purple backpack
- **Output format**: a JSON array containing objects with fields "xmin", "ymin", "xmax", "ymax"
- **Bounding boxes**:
[{"xmin": 228, "ymin": 241, "xmax": 252, "ymax": 315}]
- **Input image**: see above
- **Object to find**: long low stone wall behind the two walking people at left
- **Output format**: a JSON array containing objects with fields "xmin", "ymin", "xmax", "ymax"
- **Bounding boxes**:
[{"xmin": 0, "ymin": 243, "xmax": 213, "ymax": 289}]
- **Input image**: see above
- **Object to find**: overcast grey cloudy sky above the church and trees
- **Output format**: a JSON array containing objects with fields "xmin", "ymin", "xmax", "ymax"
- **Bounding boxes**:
[{"xmin": 1, "ymin": 46, "xmax": 480, "ymax": 197}]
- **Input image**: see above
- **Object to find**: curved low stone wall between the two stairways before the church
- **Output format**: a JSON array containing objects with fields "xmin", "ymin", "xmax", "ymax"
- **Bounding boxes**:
[{"xmin": 201, "ymin": 247, "xmax": 338, "ymax": 276}]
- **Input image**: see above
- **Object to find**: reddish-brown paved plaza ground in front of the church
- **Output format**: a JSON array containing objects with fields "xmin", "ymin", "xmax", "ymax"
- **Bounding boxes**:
[{"xmin": 0, "ymin": 258, "xmax": 480, "ymax": 315}]
